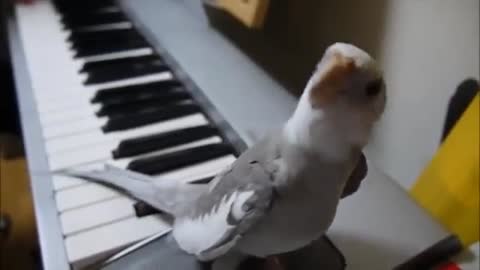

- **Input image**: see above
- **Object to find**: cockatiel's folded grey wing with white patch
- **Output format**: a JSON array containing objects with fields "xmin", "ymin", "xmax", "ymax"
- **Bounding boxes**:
[{"xmin": 173, "ymin": 160, "xmax": 275, "ymax": 261}]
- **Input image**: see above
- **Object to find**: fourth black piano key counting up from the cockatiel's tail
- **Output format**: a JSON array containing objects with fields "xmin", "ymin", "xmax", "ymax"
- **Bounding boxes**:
[{"xmin": 96, "ymin": 92, "xmax": 192, "ymax": 116}]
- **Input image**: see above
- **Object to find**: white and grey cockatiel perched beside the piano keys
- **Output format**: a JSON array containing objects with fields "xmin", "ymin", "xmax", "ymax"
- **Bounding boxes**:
[{"xmin": 70, "ymin": 43, "xmax": 386, "ymax": 269}]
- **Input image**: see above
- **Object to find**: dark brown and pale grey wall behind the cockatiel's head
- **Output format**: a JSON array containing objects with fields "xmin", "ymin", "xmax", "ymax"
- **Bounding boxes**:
[{"xmin": 208, "ymin": 0, "xmax": 479, "ymax": 188}]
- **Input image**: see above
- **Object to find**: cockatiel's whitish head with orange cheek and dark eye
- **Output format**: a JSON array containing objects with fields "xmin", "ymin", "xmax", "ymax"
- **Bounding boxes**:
[{"xmin": 305, "ymin": 43, "xmax": 386, "ymax": 122}]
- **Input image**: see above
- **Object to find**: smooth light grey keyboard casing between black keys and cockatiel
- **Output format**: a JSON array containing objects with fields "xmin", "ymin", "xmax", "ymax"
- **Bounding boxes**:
[{"xmin": 120, "ymin": 0, "xmax": 296, "ymax": 145}]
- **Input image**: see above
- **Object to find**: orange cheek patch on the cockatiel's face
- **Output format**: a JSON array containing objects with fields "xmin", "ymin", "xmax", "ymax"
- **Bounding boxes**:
[{"xmin": 310, "ymin": 53, "xmax": 355, "ymax": 107}]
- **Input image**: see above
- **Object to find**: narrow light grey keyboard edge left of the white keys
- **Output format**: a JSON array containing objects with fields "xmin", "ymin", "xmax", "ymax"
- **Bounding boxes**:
[{"xmin": 8, "ymin": 4, "xmax": 70, "ymax": 270}]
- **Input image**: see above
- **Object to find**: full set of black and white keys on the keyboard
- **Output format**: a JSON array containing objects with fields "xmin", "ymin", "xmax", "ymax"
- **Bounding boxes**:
[{"xmin": 16, "ymin": 0, "xmax": 240, "ymax": 269}]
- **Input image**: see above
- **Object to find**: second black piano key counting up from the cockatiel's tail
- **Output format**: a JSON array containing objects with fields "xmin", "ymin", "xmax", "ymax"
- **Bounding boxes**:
[{"xmin": 112, "ymin": 125, "xmax": 218, "ymax": 159}]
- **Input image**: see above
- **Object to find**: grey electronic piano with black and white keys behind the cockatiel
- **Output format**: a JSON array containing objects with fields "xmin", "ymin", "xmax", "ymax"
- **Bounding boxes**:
[{"xmin": 8, "ymin": 0, "xmax": 446, "ymax": 270}]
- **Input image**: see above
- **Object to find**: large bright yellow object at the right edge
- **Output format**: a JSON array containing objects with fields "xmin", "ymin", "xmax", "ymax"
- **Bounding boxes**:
[{"xmin": 411, "ymin": 94, "xmax": 480, "ymax": 247}]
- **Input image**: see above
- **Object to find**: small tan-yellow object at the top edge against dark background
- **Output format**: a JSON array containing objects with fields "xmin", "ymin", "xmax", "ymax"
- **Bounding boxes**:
[{"xmin": 217, "ymin": 0, "xmax": 270, "ymax": 28}]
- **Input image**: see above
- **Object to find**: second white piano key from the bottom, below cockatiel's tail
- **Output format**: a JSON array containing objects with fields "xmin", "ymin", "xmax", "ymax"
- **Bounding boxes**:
[{"xmin": 60, "ymin": 197, "xmax": 136, "ymax": 236}]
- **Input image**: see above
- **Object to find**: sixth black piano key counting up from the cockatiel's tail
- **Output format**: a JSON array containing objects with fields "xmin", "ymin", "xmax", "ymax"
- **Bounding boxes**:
[{"xmin": 84, "ymin": 59, "xmax": 169, "ymax": 85}]
